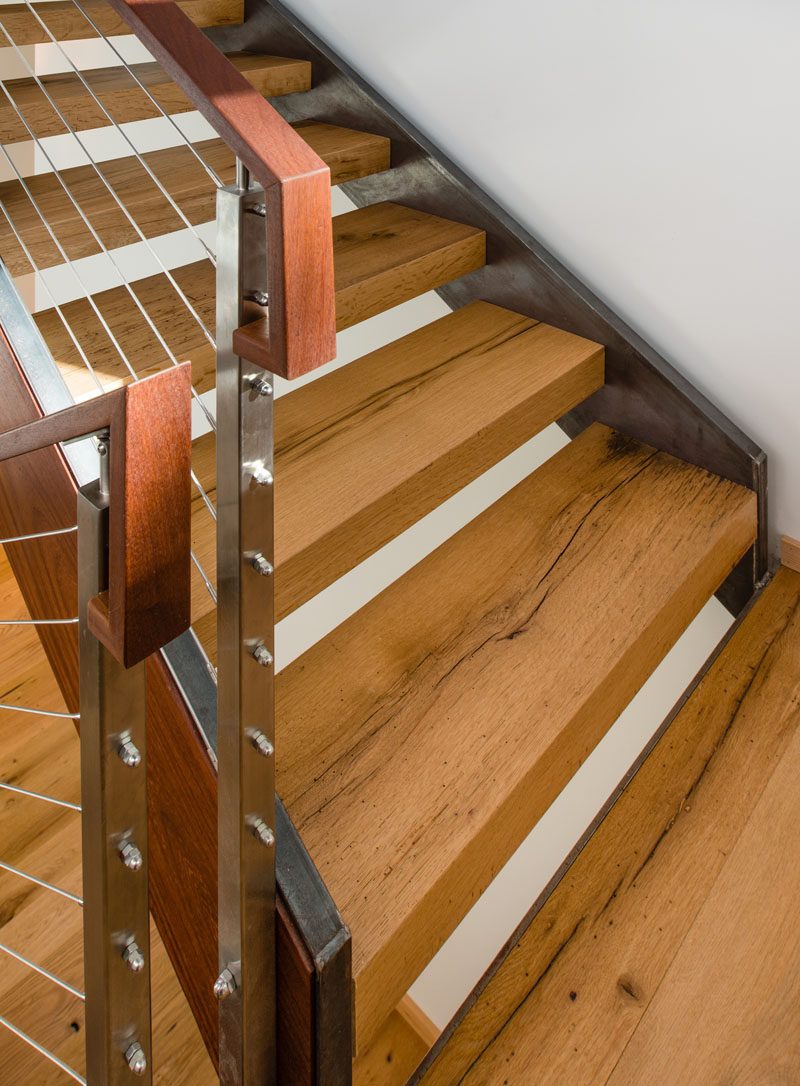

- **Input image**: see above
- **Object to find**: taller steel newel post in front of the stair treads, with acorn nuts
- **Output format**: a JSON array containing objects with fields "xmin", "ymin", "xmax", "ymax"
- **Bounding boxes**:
[{"xmin": 215, "ymin": 157, "xmax": 276, "ymax": 1086}]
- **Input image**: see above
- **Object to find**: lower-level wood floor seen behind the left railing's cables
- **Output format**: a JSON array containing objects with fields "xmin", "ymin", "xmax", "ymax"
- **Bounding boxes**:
[{"xmin": 0, "ymin": 548, "xmax": 217, "ymax": 1086}]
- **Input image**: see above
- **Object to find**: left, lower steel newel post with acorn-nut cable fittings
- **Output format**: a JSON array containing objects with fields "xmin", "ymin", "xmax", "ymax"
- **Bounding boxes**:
[{"xmin": 78, "ymin": 442, "xmax": 152, "ymax": 1086}]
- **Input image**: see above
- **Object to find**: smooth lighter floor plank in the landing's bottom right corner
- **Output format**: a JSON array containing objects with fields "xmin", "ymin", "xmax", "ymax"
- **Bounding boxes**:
[{"xmin": 609, "ymin": 699, "xmax": 800, "ymax": 1086}]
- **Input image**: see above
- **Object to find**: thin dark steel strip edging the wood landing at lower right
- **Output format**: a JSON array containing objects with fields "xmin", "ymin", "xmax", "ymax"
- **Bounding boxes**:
[{"xmin": 406, "ymin": 571, "xmax": 773, "ymax": 1086}]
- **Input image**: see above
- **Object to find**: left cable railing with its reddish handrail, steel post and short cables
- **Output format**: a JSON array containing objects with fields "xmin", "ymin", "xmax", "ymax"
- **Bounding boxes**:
[{"xmin": 0, "ymin": 364, "xmax": 191, "ymax": 1084}]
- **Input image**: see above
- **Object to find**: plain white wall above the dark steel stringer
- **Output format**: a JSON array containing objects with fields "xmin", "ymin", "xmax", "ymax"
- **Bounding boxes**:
[{"xmin": 287, "ymin": 0, "xmax": 800, "ymax": 538}]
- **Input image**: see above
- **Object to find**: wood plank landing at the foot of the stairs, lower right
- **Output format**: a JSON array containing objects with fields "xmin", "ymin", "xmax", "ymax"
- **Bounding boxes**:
[{"xmin": 412, "ymin": 569, "xmax": 800, "ymax": 1086}]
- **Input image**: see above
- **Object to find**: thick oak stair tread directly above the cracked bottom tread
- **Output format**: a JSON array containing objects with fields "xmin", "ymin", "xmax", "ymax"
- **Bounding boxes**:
[{"xmin": 186, "ymin": 302, "xmax": 604, "ymax": 634}]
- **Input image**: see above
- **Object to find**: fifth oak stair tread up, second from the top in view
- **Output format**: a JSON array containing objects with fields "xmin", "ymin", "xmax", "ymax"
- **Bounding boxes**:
[{"xmin": 0, "ymin": 53, "xmax": 312, "ymax": 143}]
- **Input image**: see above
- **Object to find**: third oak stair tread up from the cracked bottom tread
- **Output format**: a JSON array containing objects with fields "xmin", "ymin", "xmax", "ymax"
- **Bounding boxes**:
[{"xmin": 36, "ymin": 204, "xmax": 485, "ymax": 400}]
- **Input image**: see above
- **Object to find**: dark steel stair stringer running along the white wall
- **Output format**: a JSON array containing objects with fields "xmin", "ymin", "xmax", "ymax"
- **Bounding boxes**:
[{"xmin": 206, "ymin": 0, "xmax": 769, "ymax": 614}]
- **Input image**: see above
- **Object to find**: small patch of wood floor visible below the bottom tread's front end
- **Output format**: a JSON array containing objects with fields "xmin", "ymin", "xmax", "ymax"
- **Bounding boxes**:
[{"xmin": 353, "ymin": 996, "xmax": 439, "ymax": 1086}]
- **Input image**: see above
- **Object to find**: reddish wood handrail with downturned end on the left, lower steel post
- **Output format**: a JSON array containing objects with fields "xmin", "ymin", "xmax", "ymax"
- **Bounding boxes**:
[{"xmin": 0, "ymin": 362, "xmax": 191, "ymax": 667}]
